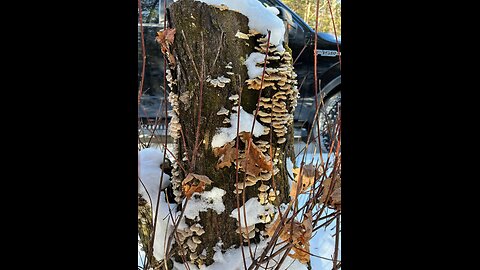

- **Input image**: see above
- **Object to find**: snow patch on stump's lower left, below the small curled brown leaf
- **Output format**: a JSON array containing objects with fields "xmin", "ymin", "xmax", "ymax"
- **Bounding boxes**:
[{"xmin": 184, "ymin": 187, "xmax": 226, "ymax": 219}]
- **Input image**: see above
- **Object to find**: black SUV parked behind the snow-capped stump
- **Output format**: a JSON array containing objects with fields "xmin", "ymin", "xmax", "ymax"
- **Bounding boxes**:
[{"xmin": 138, "ymin": 0, "xmax": 341, "ymax": 150}]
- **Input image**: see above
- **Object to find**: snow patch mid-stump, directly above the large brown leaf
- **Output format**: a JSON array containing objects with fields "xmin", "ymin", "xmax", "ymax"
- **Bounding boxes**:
[{"xmin": 212, "ymin": 107, "xmax": 265, "ymax": 148}]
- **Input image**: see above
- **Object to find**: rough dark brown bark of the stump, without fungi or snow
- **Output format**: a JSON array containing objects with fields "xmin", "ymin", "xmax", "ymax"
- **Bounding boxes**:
[{"xmin": 169, "ymin": 0, "xmax": 293, "ymax": 265}]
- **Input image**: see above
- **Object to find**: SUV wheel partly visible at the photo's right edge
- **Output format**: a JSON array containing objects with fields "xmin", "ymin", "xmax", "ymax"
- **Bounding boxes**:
[{"xmin": 311, "ymin": 92, "xmax": 342, "ymax": 153}]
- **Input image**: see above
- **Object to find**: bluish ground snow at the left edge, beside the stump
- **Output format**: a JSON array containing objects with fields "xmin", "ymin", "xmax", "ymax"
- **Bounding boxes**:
[{"xmin": 138, "ymin": 148, "xmax": 170, "ymax": 208}]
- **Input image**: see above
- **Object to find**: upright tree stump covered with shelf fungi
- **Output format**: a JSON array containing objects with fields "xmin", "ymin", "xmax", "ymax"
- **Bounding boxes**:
[{"xmin": 158, "ymin": 0, "xmax": 298, "ymax": 266}]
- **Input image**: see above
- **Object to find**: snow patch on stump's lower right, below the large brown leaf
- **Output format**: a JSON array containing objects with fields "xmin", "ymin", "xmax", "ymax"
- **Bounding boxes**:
[{"xmin": 230, "ymin": 197, "xmax": 276, "ymax": 227}]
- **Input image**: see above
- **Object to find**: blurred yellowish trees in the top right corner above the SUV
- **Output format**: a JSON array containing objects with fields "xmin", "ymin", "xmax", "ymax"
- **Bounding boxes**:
[{"xmin": 282, "ymin": 0, "xmax": 342, "ymax": 36}]
